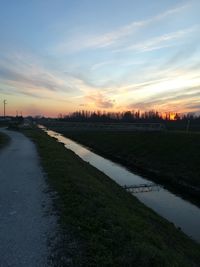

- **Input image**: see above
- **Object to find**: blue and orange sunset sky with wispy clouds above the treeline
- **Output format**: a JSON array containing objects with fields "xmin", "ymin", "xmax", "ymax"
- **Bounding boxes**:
[{"xmin": 0, "ymin": 0, "xmax": 200, "ymax": 117}]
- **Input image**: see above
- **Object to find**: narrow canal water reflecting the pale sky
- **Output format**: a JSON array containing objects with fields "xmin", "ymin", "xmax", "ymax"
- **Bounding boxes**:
[{"xmin": 41, "ymin": 126, "xmax": 200, "ymax": 242}]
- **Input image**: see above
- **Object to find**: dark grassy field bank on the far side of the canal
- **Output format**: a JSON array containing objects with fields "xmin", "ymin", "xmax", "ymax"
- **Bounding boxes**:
[{"xmin": 53, "ymin": 131, "xmax": 200, "ymax": 204}]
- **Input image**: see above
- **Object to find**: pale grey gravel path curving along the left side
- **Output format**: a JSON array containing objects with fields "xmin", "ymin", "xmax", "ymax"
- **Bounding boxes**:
[{"xmin": 0, "ymin": 129, "xmax": 56, "ymax": 267}]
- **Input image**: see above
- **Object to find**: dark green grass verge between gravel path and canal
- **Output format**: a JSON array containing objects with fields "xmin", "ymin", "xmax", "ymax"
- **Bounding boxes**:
[{"xmin": 22, "ymin": 129, "xmax": 200, "ymax": 267}]
